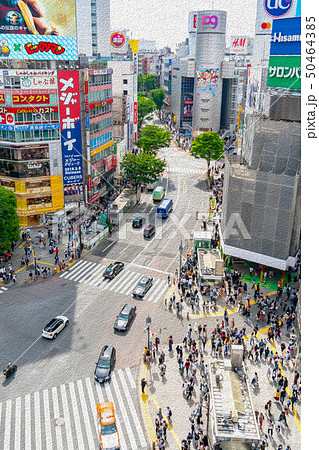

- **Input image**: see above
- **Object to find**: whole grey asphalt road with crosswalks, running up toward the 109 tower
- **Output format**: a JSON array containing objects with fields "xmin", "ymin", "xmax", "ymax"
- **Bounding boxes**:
[{"xmin": 0, "ymin": 148, "xmax": 209, "ymax": 450}]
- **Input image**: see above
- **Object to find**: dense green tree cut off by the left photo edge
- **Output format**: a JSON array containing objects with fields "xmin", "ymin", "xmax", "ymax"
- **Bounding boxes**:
[{"xmin": 0, "ymin": 186, "xmax": 20, "ymax": 253}]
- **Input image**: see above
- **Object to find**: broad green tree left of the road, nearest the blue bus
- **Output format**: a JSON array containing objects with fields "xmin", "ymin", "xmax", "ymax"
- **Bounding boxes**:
[{"xmin": 121, "ymin": 152, "xmax": 166, "ymax": 192}]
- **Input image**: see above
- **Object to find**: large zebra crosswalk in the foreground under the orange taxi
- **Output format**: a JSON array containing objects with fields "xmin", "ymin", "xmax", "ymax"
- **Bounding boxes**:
[{"xmin": 0, "ymin": 367, "xmax": 148, "ymax": 450}]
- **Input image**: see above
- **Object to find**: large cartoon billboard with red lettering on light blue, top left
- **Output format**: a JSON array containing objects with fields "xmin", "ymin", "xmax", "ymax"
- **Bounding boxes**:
[{"xmin": 0, "ymin": 0, "xmax": 77, "ymax": 60}]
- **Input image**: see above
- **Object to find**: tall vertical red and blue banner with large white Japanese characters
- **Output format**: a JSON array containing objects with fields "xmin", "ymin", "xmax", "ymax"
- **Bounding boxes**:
[{"xmin": 58, "ymin": 70, "xmax": 83, "ymax": 195}]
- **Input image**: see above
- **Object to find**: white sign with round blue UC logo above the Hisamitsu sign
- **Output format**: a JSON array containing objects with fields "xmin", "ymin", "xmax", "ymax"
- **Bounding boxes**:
[{"xmin": 255, "ymin": 0, "xmax": 297, "ymax": 35}]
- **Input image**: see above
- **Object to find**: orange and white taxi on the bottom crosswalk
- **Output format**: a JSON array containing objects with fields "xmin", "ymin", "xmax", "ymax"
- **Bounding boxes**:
[{"xmin": 96, "ymin": 402, "xmax": 120, "ymax": 450}]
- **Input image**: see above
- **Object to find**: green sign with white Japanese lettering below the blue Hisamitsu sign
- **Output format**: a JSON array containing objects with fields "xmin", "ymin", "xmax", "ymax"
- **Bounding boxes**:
[{"xmin": 267, "ymin": 56, "xmax": 301, "ymax": 90}]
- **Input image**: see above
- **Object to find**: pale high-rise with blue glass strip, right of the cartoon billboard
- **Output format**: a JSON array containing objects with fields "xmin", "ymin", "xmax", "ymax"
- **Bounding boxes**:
[{"xmin": 76, "ymin": 0, "xmax": 111, "ymax": 57}]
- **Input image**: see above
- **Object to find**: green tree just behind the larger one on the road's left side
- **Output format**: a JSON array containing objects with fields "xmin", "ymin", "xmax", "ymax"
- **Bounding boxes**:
[{"xmin": 136, "ymin": 125, "xmax": 172, "ymax": 155}]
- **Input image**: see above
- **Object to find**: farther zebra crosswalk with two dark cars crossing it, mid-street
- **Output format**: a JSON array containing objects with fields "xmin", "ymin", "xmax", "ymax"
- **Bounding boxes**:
[{"xmin": 60, "ymin": 260, "xmax": 168, "ymax": 303}]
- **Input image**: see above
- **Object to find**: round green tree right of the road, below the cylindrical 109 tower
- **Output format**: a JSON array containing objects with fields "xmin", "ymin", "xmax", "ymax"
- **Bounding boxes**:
[{"xmin": 190, "ymin": 132, "xmax": 225, "ymax": 170}]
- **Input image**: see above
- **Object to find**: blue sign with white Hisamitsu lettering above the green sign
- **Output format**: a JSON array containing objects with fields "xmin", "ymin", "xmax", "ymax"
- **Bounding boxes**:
[{"xmin": 270, "ymin": 17, "xmax": 301, "ymax": 56}]
